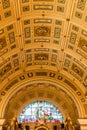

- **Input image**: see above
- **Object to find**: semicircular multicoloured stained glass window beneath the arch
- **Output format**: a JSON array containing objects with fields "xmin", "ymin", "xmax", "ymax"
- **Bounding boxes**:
[{"xmin": 18, "ymin": 100, "xmax": 63, "ymax": 123}]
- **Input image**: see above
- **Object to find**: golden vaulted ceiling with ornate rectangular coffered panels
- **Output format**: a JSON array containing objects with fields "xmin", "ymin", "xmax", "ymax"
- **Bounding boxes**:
[{"xmin": 0, "ymin": 0, "xmax": 87, "ymax": 123}]
